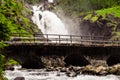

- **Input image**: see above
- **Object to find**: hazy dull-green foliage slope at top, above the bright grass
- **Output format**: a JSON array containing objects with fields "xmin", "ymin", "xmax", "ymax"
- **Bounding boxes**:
[{"xmin": 57, "ymin": 0, "xmax": 120, "ymax": 15}]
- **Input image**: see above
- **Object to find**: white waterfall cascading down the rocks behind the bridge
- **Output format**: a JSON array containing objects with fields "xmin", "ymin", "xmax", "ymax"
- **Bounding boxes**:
[{"xmin": 32, "ymin": 6, "xmax": 68, "ymax": 35}]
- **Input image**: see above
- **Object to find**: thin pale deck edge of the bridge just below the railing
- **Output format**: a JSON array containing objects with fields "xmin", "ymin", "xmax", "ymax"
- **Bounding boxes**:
[{"xmin": 5, "ymin": 42, "xmax": 120, "ymax": 47}]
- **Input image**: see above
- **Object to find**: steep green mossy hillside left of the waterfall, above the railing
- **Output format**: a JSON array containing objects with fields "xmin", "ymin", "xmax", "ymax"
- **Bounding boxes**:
[{"xmin": 0, "ymin": 0, "xmax": 37, "ymax": 40}]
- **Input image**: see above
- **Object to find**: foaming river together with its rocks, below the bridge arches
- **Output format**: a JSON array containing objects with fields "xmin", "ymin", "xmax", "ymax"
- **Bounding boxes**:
[{"xmin": 4, "ymin": 65, "xmax": 120, "ymax": 80}]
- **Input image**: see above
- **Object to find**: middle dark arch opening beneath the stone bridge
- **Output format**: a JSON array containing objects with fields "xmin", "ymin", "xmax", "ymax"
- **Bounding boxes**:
[{"xmin": 64, "ymin": 54, "xmax": 90, "ymax": 66}]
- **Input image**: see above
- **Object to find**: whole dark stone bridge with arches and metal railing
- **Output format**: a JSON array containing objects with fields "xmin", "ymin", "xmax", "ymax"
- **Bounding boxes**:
[{"xmin": 5, "ymin": 34, "xmax": 120, "ymax": 68}]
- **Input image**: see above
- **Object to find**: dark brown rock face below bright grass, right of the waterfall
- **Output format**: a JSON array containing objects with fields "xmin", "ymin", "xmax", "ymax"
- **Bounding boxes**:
[{"xmin": 80, "ymin": 16, "xmax": 115, "ymax": 40}]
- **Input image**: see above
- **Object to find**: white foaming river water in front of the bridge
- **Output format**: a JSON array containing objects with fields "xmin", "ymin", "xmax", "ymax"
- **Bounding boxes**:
[{"xmin": 4, "ymin": 66, "xmax": 119, "ymax": 80}]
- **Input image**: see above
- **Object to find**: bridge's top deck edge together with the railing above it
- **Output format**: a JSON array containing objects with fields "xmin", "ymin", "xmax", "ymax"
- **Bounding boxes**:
[{"xmin": 5, "ymin": 34, "xmax": 120, "ymax": 47}]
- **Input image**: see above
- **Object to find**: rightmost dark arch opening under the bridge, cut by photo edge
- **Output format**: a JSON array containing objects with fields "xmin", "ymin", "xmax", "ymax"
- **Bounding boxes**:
[{"xmin": 107, "ymin": 55, "xmax": 120, "ymax": 66}]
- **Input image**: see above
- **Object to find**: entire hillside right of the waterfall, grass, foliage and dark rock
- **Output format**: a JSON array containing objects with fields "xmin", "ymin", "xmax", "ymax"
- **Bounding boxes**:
[{"xmin": 55, "ymin": 0, "xmax": 120, "ymax": 40}]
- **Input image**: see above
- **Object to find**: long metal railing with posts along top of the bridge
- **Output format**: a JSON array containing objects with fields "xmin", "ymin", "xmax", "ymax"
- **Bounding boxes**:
[{"xmin": 9, "ymin": 34, "xmax": 120, "ymax": 46}]
